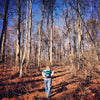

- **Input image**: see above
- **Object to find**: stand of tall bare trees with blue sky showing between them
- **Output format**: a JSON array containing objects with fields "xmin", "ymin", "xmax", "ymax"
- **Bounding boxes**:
[{"xmin": 0, "ymin": 0, "xmax": 100, "ymax": 99}]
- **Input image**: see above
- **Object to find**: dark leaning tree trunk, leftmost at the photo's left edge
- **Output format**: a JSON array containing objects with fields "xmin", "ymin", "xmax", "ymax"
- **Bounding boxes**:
[{"xmin": 0, "ymin": 0, "xmax": 10, "ymax": 62}]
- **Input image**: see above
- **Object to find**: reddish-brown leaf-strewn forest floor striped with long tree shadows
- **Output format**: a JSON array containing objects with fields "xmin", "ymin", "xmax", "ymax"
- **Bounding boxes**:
[{"xmin": 0, "ymin": 64, "xmax": 100, "ymax": 100}]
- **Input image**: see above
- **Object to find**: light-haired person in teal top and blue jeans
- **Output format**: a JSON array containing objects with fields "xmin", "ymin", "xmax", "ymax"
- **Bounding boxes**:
[{"xmin": 42, "ymin": 66, "xmax": 54, "ymax": 97}]
